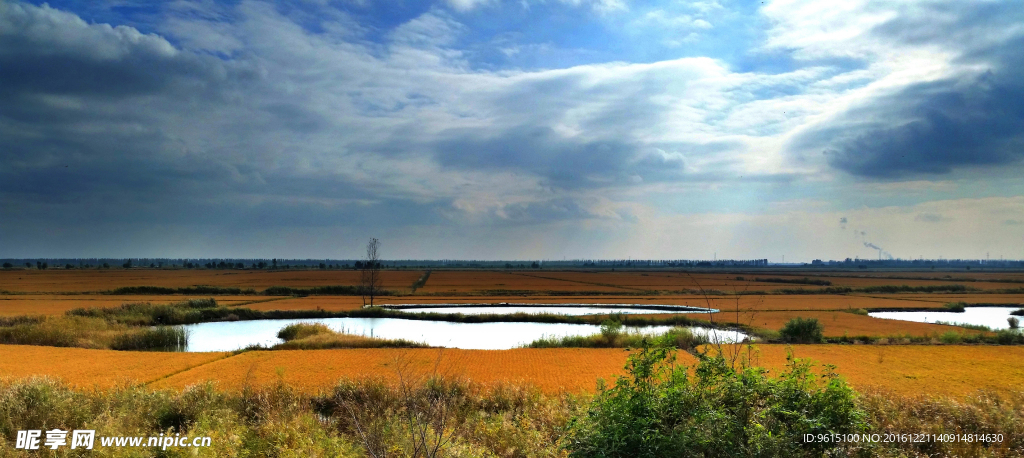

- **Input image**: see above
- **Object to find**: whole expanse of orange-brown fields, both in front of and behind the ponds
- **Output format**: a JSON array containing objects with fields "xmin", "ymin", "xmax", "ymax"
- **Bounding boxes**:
[{"xmin": 0, "ymin": 268, "xmax": 1024, "ymax": 409}]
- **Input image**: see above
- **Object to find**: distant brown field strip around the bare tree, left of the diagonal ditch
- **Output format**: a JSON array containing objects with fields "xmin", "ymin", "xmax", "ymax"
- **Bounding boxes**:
[{"xmin": 0, "ymin": 268, "xmax": 423, "ymax": 293}]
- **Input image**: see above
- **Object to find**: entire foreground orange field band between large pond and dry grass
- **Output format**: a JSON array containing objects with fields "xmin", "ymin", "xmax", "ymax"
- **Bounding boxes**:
[{"xmin": 6, "ymin": 344, "xmax": 1024, "ymax": 397}]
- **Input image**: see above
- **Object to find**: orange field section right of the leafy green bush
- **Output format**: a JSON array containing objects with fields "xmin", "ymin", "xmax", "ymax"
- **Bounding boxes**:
[{"xmin": 741, "ymin": 345, "xmax": 1024, "ymax": 397}]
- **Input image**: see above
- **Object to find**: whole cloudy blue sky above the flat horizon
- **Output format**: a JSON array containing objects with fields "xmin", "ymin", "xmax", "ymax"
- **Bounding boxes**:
[{"xmin": 0, "ymin": 0, "xmax": 1024, "ymax": 262}]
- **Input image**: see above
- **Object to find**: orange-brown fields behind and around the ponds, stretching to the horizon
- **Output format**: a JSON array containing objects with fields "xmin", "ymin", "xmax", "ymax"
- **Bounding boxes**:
[{"xmin": 0, "ymin": 268, "xmax": 1024, "ymax": 336}]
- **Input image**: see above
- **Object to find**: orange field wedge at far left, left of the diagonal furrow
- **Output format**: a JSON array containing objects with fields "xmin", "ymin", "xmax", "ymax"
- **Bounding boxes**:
[{"xmin": 0, "ymin": 345, "xmax": 229, "ymax": 387}]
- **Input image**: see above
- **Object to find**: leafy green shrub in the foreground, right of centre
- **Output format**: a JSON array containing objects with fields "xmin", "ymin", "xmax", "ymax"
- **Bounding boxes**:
[{"xmin": 563, "ymin": 343, "xmax": 866, "ymax": 458}]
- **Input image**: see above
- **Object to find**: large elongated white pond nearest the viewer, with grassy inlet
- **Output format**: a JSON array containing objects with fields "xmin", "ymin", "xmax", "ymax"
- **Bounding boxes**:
[{"xmin": 184, "ymin": 318, "xmax": 746, "ymax": 351}]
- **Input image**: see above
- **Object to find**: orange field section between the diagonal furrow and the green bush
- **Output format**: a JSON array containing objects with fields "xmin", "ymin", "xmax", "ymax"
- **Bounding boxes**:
[{"xmin": 154, "ymin": 348, "xmax": 659, "ymax": 393}]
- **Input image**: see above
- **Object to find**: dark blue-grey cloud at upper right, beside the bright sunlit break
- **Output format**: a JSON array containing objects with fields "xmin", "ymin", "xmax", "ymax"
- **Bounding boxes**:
[{"xmin": 792, "ymin": 2, "xmax": 1024, "ymax": 178}]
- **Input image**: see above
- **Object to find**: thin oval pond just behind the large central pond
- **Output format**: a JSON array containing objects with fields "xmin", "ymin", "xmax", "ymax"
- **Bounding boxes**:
[{"xmin": 381, "ymin": 302, "xmax": 718, "ymax": 315}]
